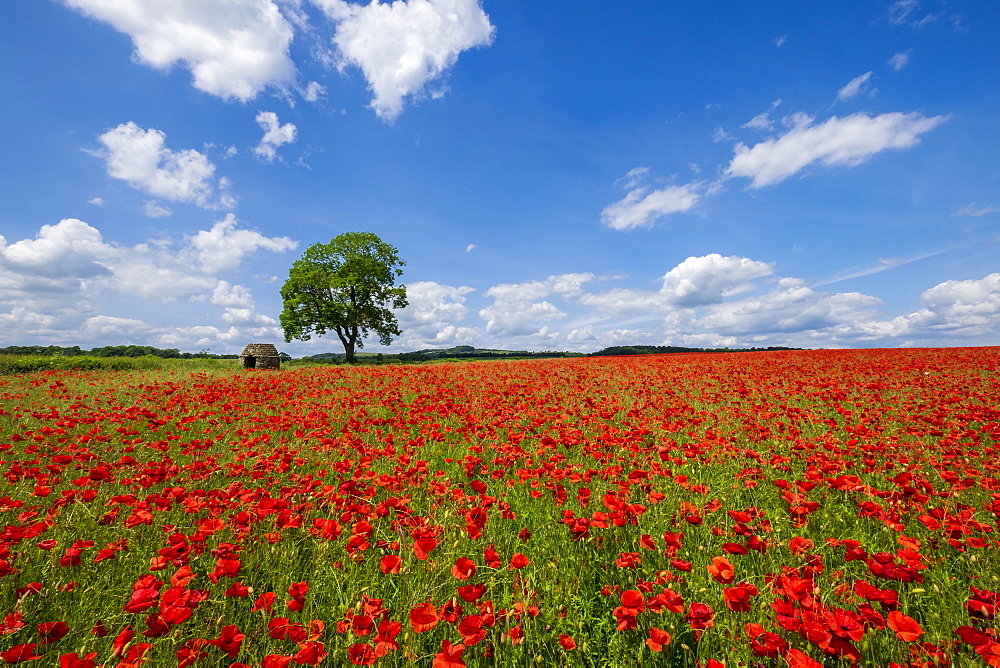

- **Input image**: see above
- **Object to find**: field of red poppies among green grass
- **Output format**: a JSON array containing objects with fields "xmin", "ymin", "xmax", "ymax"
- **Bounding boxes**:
[{"xmin": 0, "ymin": 348, "xmax": 1000, "ymax": 668}]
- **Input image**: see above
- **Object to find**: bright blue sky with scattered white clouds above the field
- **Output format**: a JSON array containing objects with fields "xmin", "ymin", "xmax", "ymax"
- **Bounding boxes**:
[{"xmin": 0, "ymin": 0, "xmax": 1000, "ymax": 355}]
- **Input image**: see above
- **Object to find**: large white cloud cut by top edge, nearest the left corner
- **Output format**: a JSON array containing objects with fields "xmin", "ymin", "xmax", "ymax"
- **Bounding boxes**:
[{"xmin": 63, "ymin": 0, "xmax": 295, "ymax": 102}]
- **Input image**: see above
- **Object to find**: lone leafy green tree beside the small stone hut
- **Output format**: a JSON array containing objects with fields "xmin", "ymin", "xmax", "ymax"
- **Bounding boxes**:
[{"xmin": 280, "ymin": 232, "xmax": 407, "ymax": 362}]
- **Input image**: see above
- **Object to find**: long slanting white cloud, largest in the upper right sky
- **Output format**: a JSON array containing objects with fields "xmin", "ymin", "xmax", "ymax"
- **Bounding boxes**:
[{"xmin": 725, "ymin": 112, "xmax": 947, "ymax": 188}]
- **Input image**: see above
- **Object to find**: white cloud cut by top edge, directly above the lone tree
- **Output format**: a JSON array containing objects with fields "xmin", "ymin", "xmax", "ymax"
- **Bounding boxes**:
[{"xmin": 313, "ymin": 0, "xmax": 494, "ymax": 121}]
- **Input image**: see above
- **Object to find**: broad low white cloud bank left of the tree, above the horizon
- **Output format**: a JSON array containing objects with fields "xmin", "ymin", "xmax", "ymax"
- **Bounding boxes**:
[{"xmin": 0, "ymin": 216, "xmax": 295, "ymax": 349}]
